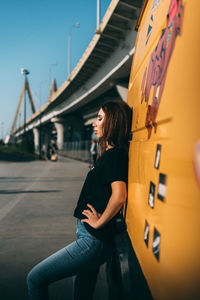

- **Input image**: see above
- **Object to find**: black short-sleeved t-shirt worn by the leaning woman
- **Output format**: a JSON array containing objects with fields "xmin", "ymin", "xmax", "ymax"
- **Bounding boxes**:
[{"xmin": 74, "ymin": 148, "xmax": 128, "ymax": 242}]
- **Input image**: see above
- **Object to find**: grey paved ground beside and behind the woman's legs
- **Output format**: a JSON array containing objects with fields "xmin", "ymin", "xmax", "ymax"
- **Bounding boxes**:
[{"xmin": 0, "ymin": 158, "xmax": 107, "ymax": 300}]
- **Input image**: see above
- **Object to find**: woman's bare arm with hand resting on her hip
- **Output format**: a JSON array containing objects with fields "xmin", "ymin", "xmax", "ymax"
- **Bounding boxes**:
[{"xmin": 82, "ymin": 181, "xmax": 127, "ymax": 229}]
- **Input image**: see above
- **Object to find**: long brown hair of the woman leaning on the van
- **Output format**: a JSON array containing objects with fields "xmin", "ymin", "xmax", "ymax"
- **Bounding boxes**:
[{"xmin": 99, "ymin": 100, "xmax": 132, "ymax": 155}]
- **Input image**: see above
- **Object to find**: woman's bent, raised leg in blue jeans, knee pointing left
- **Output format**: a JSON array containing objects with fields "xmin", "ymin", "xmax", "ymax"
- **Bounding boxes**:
[{"xmin": 27, "ymin": 225, "xmax": 110, "ymax": 300}]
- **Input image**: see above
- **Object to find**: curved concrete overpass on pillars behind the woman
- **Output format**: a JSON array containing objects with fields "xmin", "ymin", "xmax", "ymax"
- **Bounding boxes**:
[{"xmin": 11, "ymin": 0, "xmax": 143, "ymax": 151}]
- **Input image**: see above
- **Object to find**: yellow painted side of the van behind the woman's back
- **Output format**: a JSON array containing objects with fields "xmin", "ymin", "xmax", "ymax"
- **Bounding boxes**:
[{"xmin": 126, "ymin": 0, "xmax": 200, "ymax": 300}]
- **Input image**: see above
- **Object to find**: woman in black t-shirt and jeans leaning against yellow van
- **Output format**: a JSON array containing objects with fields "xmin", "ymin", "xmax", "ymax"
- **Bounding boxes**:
[{"xmin": 27, "ymin": 101, "xmax": 132, "ymax": 300}]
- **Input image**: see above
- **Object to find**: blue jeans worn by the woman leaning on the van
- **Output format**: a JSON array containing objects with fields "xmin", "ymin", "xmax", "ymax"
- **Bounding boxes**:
[{"xmin": 27, "ymin": 220, "xmax": 112, "ymax": 300}]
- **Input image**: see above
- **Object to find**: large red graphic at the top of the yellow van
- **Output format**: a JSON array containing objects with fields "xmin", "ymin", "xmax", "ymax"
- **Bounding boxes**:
[{"xmin": 141, "ymin": 0, "xmax": 184, "ymax": 139}]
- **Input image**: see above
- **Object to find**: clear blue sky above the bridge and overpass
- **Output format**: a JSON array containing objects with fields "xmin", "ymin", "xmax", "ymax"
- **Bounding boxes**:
[{"xmin": 0, "ymin": 0, "xmax": 111, "ymax": 139}]
